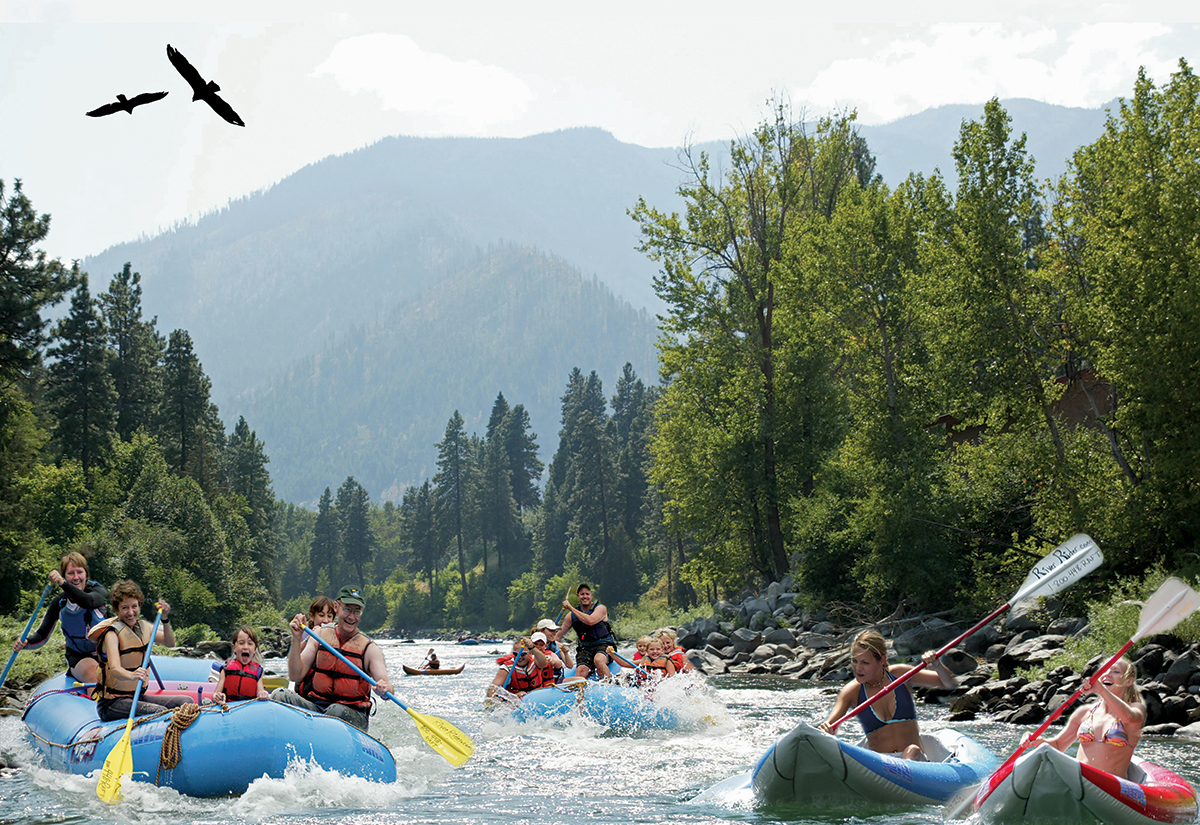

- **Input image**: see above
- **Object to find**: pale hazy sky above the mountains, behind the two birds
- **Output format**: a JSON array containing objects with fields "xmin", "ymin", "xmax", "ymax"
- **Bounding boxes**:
[{"xmin": 0, "ymin": 0, "xmax": 1200, "ymax": 261}]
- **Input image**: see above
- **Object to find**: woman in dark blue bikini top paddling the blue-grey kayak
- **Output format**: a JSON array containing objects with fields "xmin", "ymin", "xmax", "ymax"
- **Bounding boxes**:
[{"xmin": 820, "ymin": 631, "xmax": 959, "ymax": 761}]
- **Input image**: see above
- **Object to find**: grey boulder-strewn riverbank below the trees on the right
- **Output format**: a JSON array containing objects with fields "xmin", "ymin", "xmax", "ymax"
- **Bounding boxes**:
[{"xmin": 678, "ymin": 580, "xmax": 1200, "ymax": 740}]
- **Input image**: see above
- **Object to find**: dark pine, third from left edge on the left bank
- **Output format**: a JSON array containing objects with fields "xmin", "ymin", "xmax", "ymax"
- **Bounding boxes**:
[{"xmin": 100, "ymin": 264, "xmax": 166, "ymax": 441}]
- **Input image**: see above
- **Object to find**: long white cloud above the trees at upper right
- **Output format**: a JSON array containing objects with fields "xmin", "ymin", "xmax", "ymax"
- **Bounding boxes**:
[{"xmin": 792, "ymin": 23, "xmax": 1175, "ymax": 124}]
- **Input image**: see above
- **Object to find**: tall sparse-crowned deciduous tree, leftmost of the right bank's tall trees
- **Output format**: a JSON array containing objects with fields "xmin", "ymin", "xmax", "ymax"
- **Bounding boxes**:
[{"xmin": 632, "ymin": 107, "xmax": 874, "ymax": 579}]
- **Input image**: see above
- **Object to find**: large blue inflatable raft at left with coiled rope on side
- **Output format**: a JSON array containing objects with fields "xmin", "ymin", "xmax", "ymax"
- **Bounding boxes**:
[{"xmin": 23, "ymin": 657, "xmax": 396, "ymax": 796}]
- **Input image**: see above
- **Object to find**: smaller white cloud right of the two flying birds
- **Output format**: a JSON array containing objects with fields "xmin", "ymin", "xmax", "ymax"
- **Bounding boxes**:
[{"xmin": 313, "ymin": 32, "xmax": 535, "ymax": 134}]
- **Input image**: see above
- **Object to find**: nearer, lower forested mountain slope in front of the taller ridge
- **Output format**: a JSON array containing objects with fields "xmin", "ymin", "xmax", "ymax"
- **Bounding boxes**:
[{"xmin": 238, "ymin": 248, "xmax": 655, "ymax": 504}]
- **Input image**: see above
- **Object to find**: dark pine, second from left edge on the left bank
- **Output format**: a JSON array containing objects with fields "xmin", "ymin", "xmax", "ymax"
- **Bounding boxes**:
[{"xmin": 47, "ymin": 275, "xmax": 116, "ymax": 486}]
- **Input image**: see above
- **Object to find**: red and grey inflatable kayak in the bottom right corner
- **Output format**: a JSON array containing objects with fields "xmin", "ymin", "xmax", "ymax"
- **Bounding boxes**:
[{"xmin": 974, "ymin": 745, "xmax": 1198, "ymax": 825}]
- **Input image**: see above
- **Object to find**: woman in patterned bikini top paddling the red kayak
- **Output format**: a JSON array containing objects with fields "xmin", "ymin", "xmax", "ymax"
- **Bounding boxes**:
[{"xmin": 1031, "ymin": 658, "xmax": 1146, "ymax": 778}]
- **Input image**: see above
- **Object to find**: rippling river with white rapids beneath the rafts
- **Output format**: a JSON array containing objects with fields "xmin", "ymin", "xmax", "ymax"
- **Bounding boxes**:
[{"xmin": 0, "ymin": 642, "xmax": 1200, "ymax": 825}]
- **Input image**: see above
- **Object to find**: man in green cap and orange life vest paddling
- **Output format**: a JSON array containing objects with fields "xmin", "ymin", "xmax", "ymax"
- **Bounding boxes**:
[{"xmin": 271, "ymin": 585, "xmax": 391, "ymax": 730}]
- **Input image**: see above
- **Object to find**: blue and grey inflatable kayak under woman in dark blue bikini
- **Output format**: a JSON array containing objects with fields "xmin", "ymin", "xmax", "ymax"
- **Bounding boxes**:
[{"xmin": 702, "ymin": 722, "xmax": 997, "ymax": 807}]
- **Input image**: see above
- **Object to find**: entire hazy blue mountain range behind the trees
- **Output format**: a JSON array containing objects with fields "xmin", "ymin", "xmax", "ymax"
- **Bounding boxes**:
[{"xmin": 84, "ymin": 100, "xmax": 1105, "ymax": 504}]
